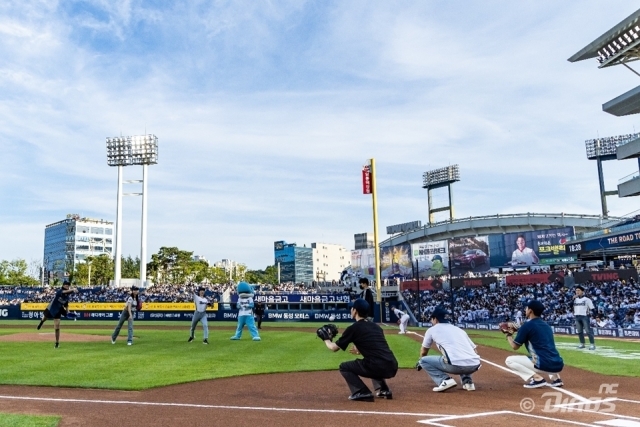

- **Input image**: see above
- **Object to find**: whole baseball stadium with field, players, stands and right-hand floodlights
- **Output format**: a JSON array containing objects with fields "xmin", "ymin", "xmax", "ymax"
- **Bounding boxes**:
[{"xmin": 6, "ymin": 6, "xmax": 640, "ymax": 427}]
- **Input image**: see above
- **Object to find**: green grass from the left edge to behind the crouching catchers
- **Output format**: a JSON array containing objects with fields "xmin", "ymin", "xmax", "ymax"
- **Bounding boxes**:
[{"xmin": 0, "ymin": 321, "xmax": 420, "ymax": 390}]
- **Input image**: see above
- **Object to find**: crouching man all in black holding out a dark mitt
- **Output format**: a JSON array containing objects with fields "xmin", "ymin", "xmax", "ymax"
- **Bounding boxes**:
[{"xmin": 317, "ymin": 298, "xmax": 398, "ymax": 402}]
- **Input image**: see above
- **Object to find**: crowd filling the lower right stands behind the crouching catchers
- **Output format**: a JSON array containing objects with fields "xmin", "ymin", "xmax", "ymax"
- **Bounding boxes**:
[{"xmin": 403, "ymin": 281, "xmax": 640, "ymax": 328}]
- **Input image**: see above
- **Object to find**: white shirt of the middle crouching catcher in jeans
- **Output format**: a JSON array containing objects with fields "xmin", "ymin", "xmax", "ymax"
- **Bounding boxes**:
[{"xmin": 422, "ymin": 323, "xmax": 480, "ymax": 366}]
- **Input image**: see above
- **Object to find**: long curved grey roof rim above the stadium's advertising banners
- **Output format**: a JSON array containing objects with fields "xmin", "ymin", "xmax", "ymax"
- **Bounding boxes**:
[{"xmin": 380, "ymin": 213, "xmax": 623, "ymax": 247}]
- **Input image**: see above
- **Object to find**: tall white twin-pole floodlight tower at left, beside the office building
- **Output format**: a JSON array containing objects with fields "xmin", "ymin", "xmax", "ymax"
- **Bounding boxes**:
[{"xmin": 107, "ymin": 134, "xmax": 158, "ymax": 286}]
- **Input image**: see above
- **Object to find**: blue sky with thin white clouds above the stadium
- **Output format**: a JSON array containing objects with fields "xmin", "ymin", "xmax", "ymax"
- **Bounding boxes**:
[{"xmin": 0, "ymin": 0, "xmax": 640, "ymax": 269}]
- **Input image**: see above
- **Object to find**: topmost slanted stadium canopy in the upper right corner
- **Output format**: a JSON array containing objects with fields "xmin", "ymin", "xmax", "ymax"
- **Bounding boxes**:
[{"xmin": 568, "ymin": 9, "xmax": 640, "ymax": 68}]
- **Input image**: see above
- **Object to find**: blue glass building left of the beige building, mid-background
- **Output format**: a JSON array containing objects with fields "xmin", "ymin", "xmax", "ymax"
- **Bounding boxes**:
[{"xmin": 273, "ymin": 240, "xmax": 315, "ymax": 285}]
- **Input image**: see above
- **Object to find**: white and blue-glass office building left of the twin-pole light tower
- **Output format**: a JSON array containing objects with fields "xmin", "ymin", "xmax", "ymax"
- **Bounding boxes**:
[{"xmin": 43, "ymin": 214, "xmax": 114, "ymax": 283}]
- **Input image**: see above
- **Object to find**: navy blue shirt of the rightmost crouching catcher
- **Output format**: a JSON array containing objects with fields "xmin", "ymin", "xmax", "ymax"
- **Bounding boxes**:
[{"xmin": 513, "ymin": 317, "xmax": 564, "ymax": 373}]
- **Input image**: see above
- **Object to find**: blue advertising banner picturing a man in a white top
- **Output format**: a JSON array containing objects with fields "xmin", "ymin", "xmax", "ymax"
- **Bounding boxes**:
[{"xmin": 489, "ymin": 227, "xmax": 574, "ymax": 267}]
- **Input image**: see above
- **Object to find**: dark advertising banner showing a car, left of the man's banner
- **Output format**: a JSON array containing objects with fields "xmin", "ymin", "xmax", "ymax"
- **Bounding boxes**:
[{"xmin": 449, "ymin": 236, "xmax": 490, "ymax": 276}]
